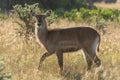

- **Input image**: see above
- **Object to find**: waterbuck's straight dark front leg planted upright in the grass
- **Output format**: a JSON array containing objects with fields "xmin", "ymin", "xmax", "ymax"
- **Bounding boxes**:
[{"xmin": 56, "ymin": 51, "xmax": 63, "ymax": 74}]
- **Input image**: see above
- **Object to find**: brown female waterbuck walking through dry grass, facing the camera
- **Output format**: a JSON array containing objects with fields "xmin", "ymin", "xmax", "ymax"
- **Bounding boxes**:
[{"xmin": 32, "ymin": 11, "xmax": 101, "ymax": 71}]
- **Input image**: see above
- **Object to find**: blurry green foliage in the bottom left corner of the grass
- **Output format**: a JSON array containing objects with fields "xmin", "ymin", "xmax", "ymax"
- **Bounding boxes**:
[{"xmin": 0, "ymin": 59, "xmax": 12, "ymax": 80}]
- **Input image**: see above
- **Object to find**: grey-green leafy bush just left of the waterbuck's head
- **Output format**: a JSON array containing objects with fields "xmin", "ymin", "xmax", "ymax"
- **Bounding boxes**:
[{"xmin": 14, "ymin": 3, "xmax": 39, "ymax": 39}]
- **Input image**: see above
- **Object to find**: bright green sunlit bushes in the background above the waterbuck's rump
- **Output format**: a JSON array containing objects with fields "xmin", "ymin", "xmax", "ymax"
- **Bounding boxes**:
[{"xmin": 64, "ymin": 8, "xmax": 120, "ymax": 21}]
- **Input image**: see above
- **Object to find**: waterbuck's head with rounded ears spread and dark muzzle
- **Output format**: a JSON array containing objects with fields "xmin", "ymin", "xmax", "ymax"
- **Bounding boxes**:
[{"xmin": 31, "ymin": 10, "xmax": 51, "ymax": 28}]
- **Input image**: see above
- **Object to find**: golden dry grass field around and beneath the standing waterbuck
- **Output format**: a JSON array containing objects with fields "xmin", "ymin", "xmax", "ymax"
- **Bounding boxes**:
[{"xmin": 0, "ymin": 18, "xmax": 120, "ymax": 80}]
